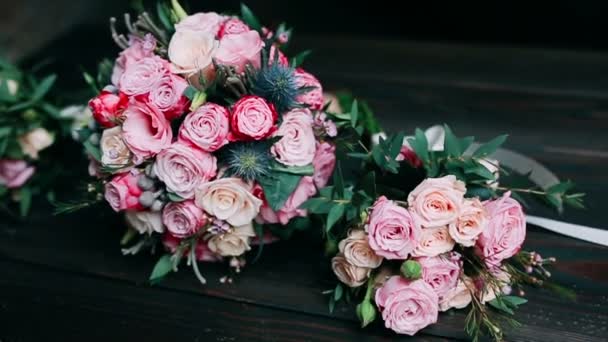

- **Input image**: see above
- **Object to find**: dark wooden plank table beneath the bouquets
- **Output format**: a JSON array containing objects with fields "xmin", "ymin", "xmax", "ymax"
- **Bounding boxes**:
[{"xmin": 0, "ymin": 32, "xmax": 608, "ymax": 342}]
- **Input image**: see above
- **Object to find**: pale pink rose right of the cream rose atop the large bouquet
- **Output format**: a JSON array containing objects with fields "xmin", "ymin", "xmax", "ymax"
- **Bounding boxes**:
[{"xmin": 215, "ymin": 31, "xmax": 264, "ymax": 73}]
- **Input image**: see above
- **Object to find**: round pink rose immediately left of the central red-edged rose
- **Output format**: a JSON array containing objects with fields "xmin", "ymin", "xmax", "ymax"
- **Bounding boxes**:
[{"xmin": 179, "ymin": 102, "xmax": 230, "ymax": 152}]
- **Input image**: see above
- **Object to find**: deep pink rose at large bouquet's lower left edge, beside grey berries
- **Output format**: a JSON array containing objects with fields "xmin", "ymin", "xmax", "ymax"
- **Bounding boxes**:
[{"xmin": 105, "ymin": 172, "xmax": 143, "ymax": 212}]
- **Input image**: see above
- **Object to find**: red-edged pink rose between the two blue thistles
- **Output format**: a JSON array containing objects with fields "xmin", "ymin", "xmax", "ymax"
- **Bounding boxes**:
[{"xmin": 229, "ymin": 95, "xmax": 277, "ymax": 141}]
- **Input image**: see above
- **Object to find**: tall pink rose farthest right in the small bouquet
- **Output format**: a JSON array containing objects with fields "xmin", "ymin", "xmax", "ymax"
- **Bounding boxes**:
[{"xmin": 477, "ymin": 192, "xmax": 526, "ymax": 267}]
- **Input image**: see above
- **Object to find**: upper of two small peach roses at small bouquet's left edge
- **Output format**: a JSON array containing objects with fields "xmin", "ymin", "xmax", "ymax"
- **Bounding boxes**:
[{"xmin": 338, "ymin": 229, "xmax": 383, "ymax": 268}]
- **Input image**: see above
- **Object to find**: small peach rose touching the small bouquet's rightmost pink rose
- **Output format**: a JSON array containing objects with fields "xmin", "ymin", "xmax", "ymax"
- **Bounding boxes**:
[{"xmin": 449, "ymin": 198, "xmax": 488, "ymax": 247}]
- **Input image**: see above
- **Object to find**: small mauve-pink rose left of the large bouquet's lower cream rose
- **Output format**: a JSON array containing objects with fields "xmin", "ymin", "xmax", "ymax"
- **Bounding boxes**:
[{"xmin": 163, "ymin": 200, "xmax": 207, "ymax": 238}]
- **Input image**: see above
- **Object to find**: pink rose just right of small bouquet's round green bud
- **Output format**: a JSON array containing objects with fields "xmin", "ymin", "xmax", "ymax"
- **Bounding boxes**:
[{"xmin": 417, "ymin": 253, "xmax": 462, "ymax": 301}]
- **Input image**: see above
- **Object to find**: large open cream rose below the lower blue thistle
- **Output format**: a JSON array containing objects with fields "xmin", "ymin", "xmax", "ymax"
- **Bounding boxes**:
[{"xmin": 196, "ymin": 178, "xmax": 262, "ymax": 227}]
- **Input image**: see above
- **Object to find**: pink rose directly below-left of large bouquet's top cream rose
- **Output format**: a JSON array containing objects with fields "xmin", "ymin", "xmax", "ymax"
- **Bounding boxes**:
[{"xmin": 120, "ymin": 56, "xmax": 169, "ymax": 96}]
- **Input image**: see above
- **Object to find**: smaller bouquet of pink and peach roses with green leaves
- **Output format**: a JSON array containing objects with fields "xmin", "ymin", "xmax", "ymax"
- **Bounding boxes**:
[{"xmin": 302, "ymin": 126, "xmax": 583, "ymax": 340}]
